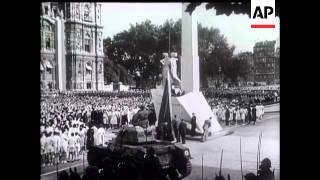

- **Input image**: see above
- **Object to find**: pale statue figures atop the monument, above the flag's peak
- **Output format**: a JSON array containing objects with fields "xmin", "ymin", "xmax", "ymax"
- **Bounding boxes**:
[{"xmin": 160, "ymin": 53, "xmax": 181, "ymax": 88}]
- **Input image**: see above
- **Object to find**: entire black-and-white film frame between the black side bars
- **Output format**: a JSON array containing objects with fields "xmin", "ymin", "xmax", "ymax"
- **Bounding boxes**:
[{"xmin": 39, "ymin": 0, "xmax": 285, "ymax": 180}]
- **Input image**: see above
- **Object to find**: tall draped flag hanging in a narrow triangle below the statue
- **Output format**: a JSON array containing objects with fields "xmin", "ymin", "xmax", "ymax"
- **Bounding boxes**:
[{"xmin": 158, "ymin": 71, "xmax": 174, "ymax": 141}]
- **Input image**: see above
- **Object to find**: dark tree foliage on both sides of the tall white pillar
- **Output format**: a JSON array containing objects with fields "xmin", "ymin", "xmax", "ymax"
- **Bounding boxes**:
[{"xmin": 104, "ymin": 19, "xmax": 250, "ymax": 87}]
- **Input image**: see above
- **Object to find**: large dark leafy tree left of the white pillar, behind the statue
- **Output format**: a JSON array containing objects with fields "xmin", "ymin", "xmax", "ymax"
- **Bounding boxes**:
[{"xmin": 105, "ymin": 20, "xmax": 181, "ymax": 87}]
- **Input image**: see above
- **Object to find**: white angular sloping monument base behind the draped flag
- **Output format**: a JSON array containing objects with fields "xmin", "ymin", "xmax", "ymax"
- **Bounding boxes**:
[{"xmin": 151, "ymin": 88, "xmax": 223, "ymax": 135}]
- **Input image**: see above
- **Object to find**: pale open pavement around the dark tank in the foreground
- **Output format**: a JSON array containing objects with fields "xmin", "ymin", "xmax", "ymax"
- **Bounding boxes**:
[{"xmin": 41, "ymin": 104, "xmax": 280, "ymax": 180}]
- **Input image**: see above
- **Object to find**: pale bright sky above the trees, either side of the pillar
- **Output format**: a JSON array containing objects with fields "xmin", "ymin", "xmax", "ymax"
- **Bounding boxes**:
[{"xmin": 102, "ymin": 3, "xmax": 280, "ymax": 53}]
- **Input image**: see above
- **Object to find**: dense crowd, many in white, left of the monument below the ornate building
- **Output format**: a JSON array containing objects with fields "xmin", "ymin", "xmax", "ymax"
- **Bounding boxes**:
[{"xmin": 40, "ymin": 91, "xmax": 151, "ymax": 166}]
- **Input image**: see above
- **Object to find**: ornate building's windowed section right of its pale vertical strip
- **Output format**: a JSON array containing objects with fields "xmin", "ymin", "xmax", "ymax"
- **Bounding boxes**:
[{"xmin": 65, "ymin": 3, "xmax": 104, "ymax": 90}]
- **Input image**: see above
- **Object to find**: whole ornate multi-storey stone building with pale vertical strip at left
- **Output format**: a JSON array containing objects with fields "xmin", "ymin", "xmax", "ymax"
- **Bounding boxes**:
[{"xmin": 40, "ymin": 2, "xmax": 104, "ymax": 90}]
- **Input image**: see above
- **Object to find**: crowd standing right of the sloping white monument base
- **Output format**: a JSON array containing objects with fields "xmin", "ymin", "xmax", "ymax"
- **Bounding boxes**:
[{"xmin": 203, "ymin": 86, "xmax": 280, "ymax": 126}]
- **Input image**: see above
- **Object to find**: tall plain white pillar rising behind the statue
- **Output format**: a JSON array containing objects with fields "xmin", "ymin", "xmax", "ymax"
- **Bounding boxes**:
[{"xmin": 181, "ymin": 3, "xmax": 200, "ymax": 93}]
